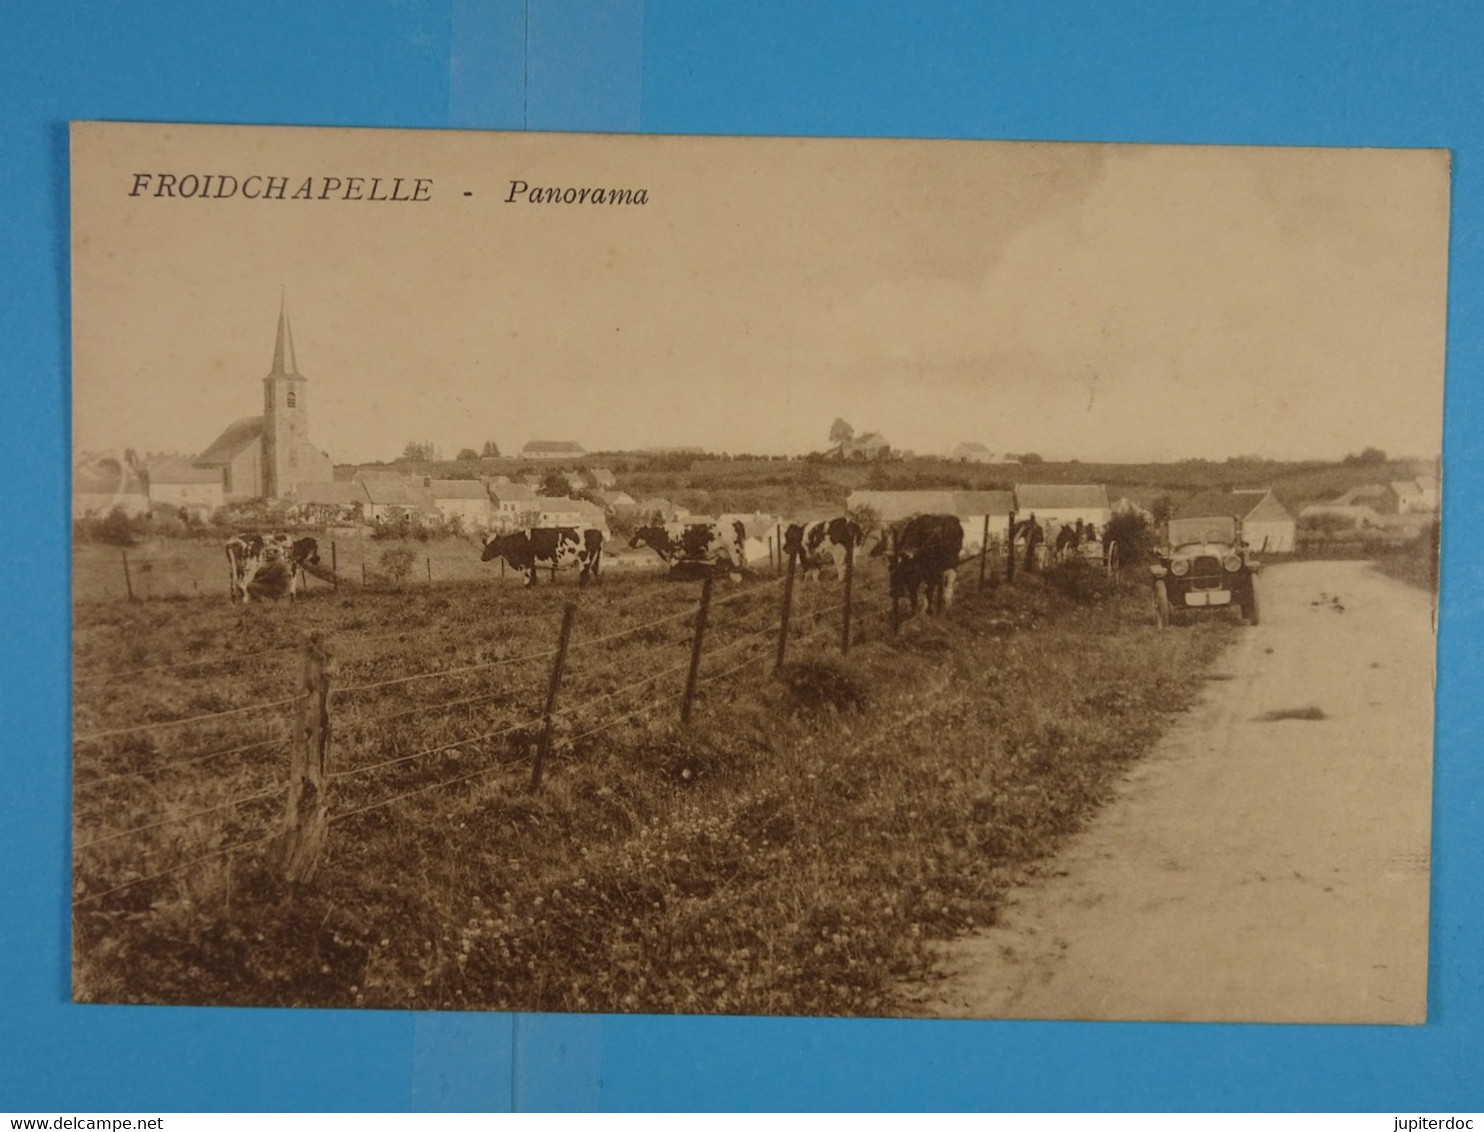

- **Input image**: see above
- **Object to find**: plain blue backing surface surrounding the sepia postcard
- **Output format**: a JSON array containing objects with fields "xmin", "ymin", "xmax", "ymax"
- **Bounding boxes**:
[{"xmin": 0, "ymin": 0, "xmax": 1484, "ymax": 1111}]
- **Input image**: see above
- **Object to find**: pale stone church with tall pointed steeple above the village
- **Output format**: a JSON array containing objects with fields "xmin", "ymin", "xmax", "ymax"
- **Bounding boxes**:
[{"xmin": 191, "ymin": 307, "xmax": 335, "ymax": 503}]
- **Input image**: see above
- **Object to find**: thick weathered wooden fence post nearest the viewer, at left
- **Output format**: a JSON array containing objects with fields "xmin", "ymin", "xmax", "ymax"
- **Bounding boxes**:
[{"xmin": 283, "ymin": 629, "xmax": 335, "ymax": 881}]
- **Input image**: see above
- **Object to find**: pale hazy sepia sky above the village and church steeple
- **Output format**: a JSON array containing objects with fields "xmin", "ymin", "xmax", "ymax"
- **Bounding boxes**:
[{"xmin": 71, "ymin": 123, "xmax": 1448, "ymax": 463}]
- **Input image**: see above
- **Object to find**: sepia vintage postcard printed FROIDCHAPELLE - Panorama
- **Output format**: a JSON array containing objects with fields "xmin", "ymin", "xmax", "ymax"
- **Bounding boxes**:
[{"xmin": 71, "ymin": 123, "xmax": 1448, "ymax": 1024}]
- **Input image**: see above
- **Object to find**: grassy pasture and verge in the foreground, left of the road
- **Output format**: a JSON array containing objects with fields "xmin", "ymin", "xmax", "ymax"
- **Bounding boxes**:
[{"xmin": 73, "ymin": 562, "xmax": 1233, "ymax": 1015}]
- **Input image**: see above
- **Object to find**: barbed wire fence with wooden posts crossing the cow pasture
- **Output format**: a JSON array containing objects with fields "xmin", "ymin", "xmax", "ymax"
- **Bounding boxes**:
[{"xmin": 73, "ymin": 528, "xmax": 1020, "ymax": 909}]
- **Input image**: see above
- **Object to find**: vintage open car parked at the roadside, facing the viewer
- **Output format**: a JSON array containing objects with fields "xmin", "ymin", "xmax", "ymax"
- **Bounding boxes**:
[{"xmin": 1150, "ymin": 515, "xmax": 1258, "ymax": 629}]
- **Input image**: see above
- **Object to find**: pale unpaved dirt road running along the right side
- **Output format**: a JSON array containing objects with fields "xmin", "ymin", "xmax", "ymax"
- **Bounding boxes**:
[{"xmin": 913, "ymin": 562, "xmax": 1434, "ymax": 1024}]
